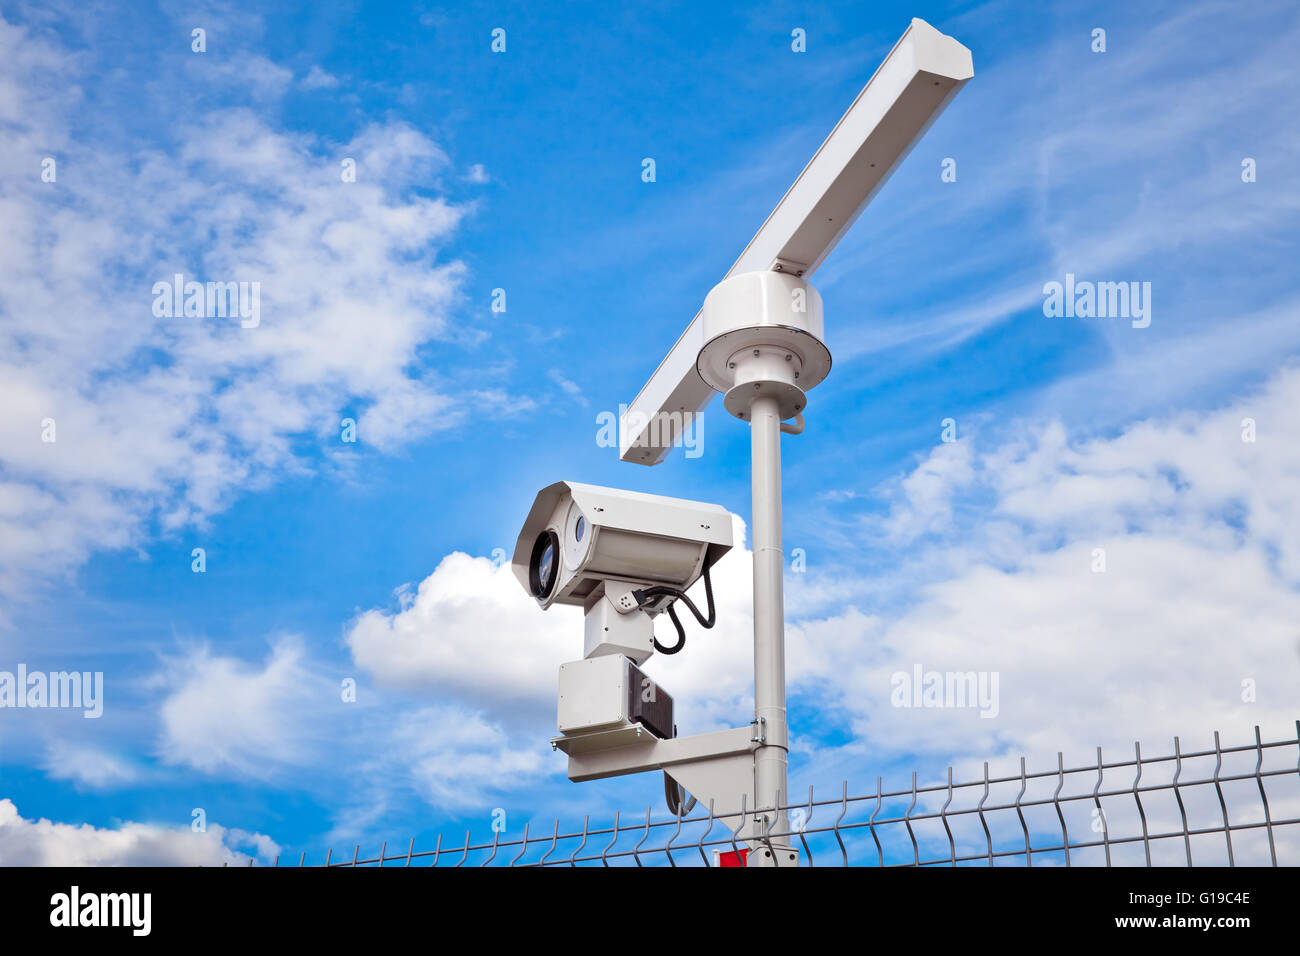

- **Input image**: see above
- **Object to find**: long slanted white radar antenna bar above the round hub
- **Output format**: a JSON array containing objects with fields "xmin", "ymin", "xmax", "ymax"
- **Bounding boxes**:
[{"xmin": 619, "ymin": 20, "xmax": 974, "ymax": 464}]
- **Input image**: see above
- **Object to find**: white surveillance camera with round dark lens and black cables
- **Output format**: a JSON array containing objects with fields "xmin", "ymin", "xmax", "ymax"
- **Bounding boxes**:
[{"xmin": 512, "ymin": 481, "xmax": 732, "ymax": 663}]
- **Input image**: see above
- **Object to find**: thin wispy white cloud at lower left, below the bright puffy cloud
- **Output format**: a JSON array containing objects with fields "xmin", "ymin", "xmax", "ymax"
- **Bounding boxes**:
[{"xmin": 139, "ymin": 624, "xmax": 558, "ymax": 840}]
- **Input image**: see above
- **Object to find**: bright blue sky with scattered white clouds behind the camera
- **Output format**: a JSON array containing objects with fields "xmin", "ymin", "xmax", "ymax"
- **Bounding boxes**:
[{"xmin": 0, "ymin": 3, "xmax": 1300, "ymax": 861}]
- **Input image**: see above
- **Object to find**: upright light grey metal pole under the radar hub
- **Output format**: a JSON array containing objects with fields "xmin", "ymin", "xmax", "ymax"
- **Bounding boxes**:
[{"xmin": 750, "ymin": 397, "xmax": 790, "ymax": 835}]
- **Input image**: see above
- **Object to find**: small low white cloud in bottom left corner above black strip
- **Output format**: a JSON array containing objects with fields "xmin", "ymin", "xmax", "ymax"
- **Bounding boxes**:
[{"xmin": 0, "ymin": 799, "xmax": 280, "ymax": 866}]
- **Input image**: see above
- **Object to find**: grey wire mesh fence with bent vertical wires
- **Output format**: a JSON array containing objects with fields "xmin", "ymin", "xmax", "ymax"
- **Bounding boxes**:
[{"xmin": 266, "ymin": 721, "xmax": 1300, "ymax": 866}]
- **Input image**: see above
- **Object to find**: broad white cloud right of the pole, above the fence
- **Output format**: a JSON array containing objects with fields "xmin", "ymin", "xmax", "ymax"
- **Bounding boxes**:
[{"xmin": 790, "ymin": 369, "xmax": 1300, "ymax": 770}]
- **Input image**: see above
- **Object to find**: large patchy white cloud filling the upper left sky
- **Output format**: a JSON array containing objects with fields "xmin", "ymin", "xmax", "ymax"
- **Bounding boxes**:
[{"xmin": 0, "ymin": 20, "xmax": 527, "ymax": 597}]
